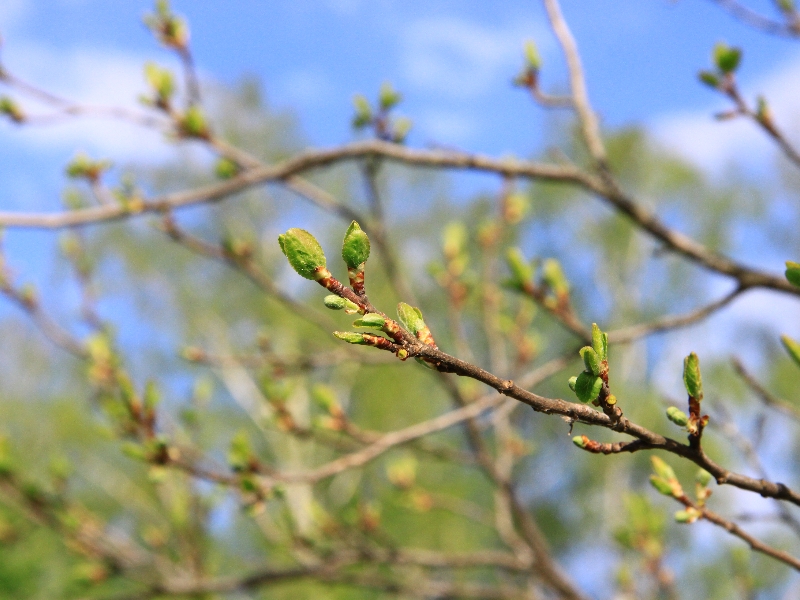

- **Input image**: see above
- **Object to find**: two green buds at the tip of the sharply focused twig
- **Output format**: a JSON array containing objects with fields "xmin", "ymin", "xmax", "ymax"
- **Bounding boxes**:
[{"xmin": 278, "ymin": 221, "xmax": 370, "ymax": 290}]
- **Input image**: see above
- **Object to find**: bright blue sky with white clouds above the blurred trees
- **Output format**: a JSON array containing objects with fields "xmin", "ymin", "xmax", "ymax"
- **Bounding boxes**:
[{"xmin": 0, "ymin": 0, "xmax": 800, "ymax": 390}]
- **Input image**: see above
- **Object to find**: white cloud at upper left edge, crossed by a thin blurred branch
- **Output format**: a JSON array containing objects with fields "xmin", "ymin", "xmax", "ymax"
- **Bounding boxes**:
[{"xmin": 0, "ymin": 42, "xmax": 186, "ymax": 162}]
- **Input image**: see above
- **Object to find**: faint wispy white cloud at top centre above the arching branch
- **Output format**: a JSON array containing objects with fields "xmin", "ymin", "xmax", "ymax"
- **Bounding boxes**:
[{"xmin": 403, "ymin": 17, "xmax": 549, "ymax": 98}]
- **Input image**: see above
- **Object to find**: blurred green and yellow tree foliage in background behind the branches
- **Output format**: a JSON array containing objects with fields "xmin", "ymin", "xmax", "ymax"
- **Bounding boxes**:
[{"xmin": 0, "ymin": 38, "xmax": 800, "ymax": 600}]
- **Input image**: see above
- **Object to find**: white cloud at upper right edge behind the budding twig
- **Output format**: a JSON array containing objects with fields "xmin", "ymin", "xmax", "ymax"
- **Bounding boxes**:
[{"xmin": 653, "ymin": 56, "xmax": 800, "ymax": 173}]
